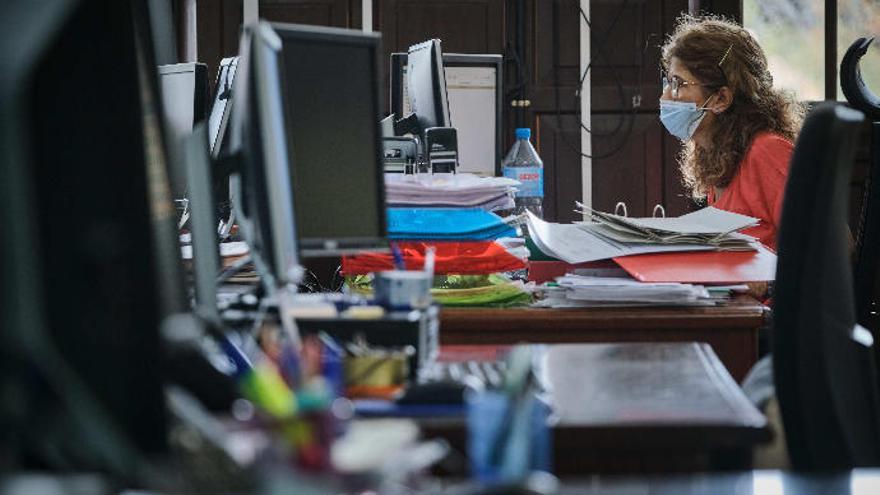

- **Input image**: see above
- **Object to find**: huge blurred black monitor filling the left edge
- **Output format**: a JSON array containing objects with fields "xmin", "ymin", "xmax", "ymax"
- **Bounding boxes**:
[{"xmin": 0, "ymin": 0, "xmax": 178, "ymax": 479}]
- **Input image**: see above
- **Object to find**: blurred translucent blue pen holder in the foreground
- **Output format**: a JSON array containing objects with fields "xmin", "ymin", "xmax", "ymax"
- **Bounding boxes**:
[{"xmin": 465, "ymin": 390, "xmax": 552, "ymax": 484}]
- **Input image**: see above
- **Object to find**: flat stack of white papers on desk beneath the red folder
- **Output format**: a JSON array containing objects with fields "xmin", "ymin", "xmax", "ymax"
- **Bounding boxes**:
[{"xmin": 539, "ymin": 274, "xmax": 719, "ymax": 308}]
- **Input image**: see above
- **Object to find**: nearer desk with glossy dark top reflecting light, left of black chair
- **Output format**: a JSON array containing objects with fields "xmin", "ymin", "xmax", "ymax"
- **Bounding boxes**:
[{"xmin": 421, "ymin": 343, "xmax": 770, "ymax": 475}]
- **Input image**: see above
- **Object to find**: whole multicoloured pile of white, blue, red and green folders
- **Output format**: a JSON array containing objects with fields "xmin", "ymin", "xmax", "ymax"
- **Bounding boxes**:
[{"xmin": 342, "ymin": 174, "xmax": 534, "ymax": 306}]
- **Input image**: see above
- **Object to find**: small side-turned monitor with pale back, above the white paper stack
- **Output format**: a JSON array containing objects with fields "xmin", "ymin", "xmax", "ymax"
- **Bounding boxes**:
[{"xmin": 407, "ymin": 39, "xmax": 452, "ymax": 132}]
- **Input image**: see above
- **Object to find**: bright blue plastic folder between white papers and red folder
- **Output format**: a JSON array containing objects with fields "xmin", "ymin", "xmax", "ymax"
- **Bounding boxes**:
[{"xmin": 388, "ymin": 208, "xmax": 516, "ymax": 241}]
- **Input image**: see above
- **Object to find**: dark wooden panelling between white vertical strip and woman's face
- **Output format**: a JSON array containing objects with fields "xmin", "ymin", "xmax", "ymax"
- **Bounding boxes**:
[{"xmin": 591, "ymin": 0, "xmax": 692, "ymax": 216}]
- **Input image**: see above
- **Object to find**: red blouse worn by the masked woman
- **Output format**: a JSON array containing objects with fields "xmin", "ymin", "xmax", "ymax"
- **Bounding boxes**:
[{"xmin": 708, "ymin": 133, "xmax": 794, "ymax": 250}]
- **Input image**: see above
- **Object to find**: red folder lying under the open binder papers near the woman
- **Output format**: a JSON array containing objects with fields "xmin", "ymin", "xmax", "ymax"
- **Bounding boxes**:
[{"xmin": 614, "ymin": 246, "xmax": 776, "ymax": 284}]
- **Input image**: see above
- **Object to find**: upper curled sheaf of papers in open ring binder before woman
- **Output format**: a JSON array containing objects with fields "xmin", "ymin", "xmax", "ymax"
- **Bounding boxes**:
[{"xmin": 577, "ymin": 203, "xmax": 758, "ymax": 250}]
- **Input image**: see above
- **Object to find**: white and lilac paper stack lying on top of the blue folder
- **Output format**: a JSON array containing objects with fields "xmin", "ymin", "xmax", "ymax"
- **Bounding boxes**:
[{"xmin": 385, "ymin": 174, "xmax": 519, "ymax": 211}]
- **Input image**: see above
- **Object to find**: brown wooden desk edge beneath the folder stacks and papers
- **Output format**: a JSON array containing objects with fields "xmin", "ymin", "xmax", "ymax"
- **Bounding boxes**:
[{"xmin": 440, "ymin": 295, "xmax": 767, "ymax": 381}]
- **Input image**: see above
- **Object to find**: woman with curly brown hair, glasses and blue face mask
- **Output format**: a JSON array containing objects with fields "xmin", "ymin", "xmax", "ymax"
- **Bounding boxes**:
[{"xmin": 660, "ymin": 16, "xmax": 804, "ymax": 249}]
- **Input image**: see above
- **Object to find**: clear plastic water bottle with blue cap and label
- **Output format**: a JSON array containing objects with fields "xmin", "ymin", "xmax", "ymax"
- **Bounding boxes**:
[{"xmin": 501, "ymin": 127, "xmax": 544, "ymax": 218}]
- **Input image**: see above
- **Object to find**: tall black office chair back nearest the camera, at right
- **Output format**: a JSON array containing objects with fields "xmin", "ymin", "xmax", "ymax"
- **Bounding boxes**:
[{"xmin": 772, "ymin": 103, "xmax": 880, "ymax": 470}]
